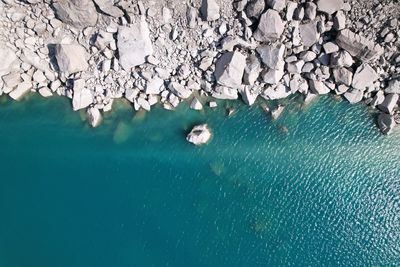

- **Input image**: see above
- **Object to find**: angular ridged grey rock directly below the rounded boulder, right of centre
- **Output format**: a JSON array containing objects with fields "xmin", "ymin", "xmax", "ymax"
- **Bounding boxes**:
[{"xmin": 256, "ymin": 44, "xmax": 285, "ymax": 69}]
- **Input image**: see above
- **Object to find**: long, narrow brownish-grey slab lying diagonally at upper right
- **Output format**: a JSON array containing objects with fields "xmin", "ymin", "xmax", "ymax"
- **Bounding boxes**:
[{"xmin": 336, "ymin": 29, "xmax": 384, "ymax": 61}]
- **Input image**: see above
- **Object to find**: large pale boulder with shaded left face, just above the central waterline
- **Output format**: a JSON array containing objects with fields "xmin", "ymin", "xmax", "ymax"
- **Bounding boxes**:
[{"xmin": 214, "ymin": 52, "xmax": 246, "ymax": 88}]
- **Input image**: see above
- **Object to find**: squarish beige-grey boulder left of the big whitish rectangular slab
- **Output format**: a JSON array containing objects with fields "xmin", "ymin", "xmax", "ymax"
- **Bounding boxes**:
[{"xmin": 56, "ymin": 44, "xmax": 89, "ymax": 73}]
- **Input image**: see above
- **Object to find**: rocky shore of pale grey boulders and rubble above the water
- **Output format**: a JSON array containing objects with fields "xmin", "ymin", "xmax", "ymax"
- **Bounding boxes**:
[{"xmin": 0, "ymin": 0, "xmax": 400, "ymax": 134}]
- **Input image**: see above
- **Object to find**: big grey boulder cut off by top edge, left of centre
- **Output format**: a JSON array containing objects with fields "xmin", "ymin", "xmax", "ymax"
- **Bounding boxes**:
[{"xmin": 53, "ymin": 0, "xmax": 97, "ymax": 29}]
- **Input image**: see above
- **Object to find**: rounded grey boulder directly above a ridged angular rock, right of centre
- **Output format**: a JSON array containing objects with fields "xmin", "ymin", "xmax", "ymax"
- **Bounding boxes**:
[{"xmin": 253, "ymin": 9, "xmax": 285, "ymax": 42}]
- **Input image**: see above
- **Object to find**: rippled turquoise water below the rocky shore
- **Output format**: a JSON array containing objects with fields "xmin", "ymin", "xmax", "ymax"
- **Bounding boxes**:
[{"xmin": 0, "ymin": 97, "xmax": 400, "ymax": 267}]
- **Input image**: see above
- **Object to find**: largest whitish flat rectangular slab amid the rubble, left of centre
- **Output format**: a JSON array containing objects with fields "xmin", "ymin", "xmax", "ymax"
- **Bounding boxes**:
[{"xmin": 118, "ymin": 18, "xmax": 153, "ymax": 70}]
